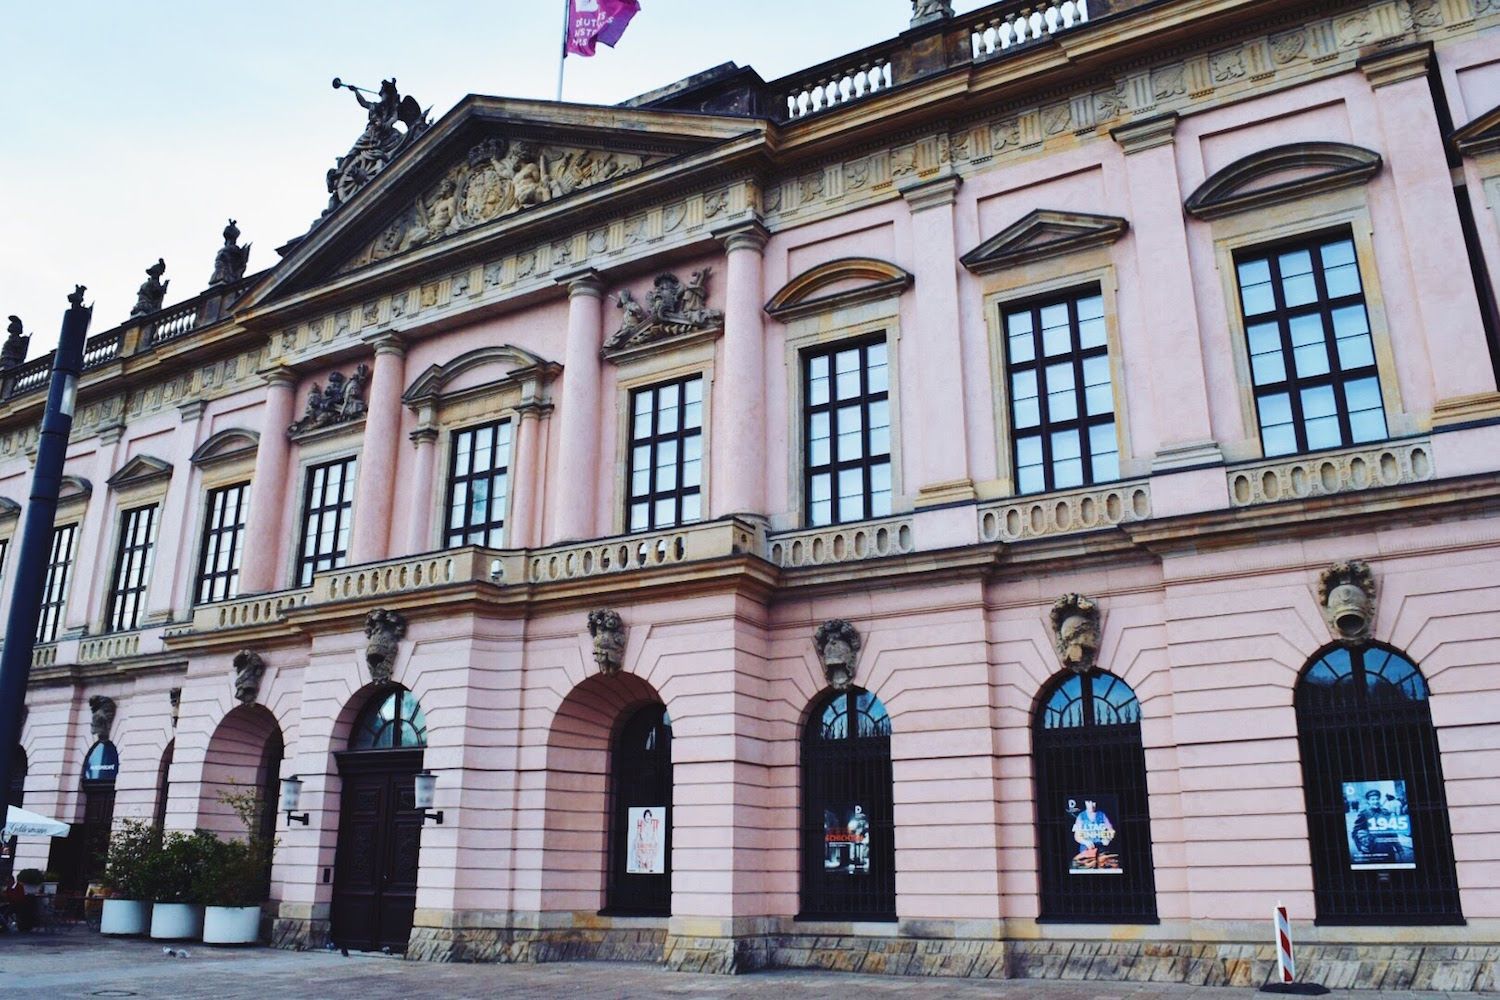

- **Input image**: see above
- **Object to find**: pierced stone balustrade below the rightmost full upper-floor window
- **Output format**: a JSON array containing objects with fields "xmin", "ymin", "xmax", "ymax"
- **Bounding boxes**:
[{"xmin": 1229, "ymin": 438, "xmax": 1436, "ymax": 507}]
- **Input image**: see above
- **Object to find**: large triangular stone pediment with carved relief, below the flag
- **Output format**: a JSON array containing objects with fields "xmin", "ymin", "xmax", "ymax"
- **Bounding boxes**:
[{"xmin": 240, "ymin": 96, "xmax": 767, "ymax": 309}]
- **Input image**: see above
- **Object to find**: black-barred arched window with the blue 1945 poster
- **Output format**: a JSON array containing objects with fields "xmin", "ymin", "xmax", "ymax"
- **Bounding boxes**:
[{"xmin": 1296, "ymin": 645, "xmax": 1464, "ymax": 924}]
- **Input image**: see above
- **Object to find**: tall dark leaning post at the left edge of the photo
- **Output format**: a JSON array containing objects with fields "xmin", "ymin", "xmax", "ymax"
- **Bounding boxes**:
[{"xmin": 0, "ymin": 285, "xmax": 93, "ymax": 807}]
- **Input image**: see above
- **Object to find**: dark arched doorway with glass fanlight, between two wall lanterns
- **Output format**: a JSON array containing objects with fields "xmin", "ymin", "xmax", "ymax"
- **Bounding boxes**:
[{"xmin": 332, "ymin": 687, "xmax": 428, "ymax": 951}]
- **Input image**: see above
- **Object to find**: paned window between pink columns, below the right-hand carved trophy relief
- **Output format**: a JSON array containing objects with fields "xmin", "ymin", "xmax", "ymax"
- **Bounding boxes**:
[{"xmin": 626, "ymin": 375, "xmax": 704, "ymax": 531}]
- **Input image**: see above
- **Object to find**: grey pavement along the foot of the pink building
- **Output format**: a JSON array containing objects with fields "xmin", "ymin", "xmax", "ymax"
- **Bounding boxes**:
[{"xmin": 0, "ymin": 931, "xmax": 1472, "ymax": 1000}]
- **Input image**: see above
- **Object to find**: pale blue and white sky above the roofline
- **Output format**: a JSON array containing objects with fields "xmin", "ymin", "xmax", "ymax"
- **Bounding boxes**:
[{"xmin": 0, "ymin": 0, "xmax": 984, "ymax": 357}]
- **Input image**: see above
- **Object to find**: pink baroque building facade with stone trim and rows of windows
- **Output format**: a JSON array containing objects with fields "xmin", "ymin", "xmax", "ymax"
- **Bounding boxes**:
[{"xmin": 0, "ymin": 0, "xmax": 1500, "ymax": 988}]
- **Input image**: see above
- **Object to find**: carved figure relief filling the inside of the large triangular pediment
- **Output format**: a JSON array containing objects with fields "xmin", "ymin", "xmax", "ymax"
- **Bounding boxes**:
[{"xmin": 342, "ymin": 138, "xmax": 665, "ymax": 271}]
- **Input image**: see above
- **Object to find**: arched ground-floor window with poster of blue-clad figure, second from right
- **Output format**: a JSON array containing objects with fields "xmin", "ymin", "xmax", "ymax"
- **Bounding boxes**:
[{"xmin": 1032, "ymin": 672, "xmax": 1157, "ymax": 924}]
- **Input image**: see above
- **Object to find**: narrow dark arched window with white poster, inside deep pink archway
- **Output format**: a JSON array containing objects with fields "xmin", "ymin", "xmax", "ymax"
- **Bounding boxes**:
[{"xmin": 605, "ymin": 705, "xmax": 672, "ymax": 916}]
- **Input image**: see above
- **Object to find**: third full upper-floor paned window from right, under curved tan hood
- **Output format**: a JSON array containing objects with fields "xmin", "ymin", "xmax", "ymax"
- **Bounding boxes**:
[{"xmin": 803, "ymin": 334, "xmax": 891, "ymax": 526}]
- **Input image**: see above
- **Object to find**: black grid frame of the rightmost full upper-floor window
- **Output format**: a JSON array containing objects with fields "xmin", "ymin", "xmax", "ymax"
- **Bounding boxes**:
[{"xmin": 1233, "ymin": 226, "xmax": 1391, "ymax": 457}]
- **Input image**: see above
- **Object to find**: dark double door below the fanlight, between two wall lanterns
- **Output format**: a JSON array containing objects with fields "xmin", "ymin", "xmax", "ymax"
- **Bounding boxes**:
[{"xmin": 332, "ymin": 750, "xmax": 423, "ymax": 952}]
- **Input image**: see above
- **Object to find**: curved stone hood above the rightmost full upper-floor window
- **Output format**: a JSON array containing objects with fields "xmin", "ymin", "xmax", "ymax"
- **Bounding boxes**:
[{"xmin": 1184, "ymin": 142, "xmax": 1382, "ymax": 219}]
